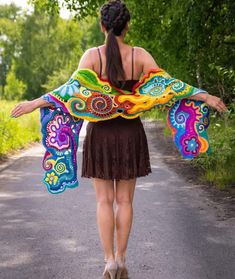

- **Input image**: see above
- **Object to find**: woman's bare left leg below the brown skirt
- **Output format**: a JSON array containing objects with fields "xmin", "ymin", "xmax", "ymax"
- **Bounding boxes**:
[{"xmin": 92, "ymin": 178, "xmax": 114, "ymax": 260}]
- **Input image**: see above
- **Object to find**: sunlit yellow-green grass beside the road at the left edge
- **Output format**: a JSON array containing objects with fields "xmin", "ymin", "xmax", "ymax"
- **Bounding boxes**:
[{"xmin": 0, "ymin": 100, "xmax": 41, "ymax": 158}]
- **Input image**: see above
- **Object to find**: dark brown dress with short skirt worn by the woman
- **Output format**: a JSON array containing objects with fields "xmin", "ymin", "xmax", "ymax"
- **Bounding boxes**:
[{"xmin": 81, "ymin": 47, "xmax": 152, "ymax": 180}]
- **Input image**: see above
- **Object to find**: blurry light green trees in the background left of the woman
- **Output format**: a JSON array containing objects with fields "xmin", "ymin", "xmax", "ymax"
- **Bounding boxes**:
[{"xmin": 0, "ymin": 1, "xmax": 104, "ymax": 100}]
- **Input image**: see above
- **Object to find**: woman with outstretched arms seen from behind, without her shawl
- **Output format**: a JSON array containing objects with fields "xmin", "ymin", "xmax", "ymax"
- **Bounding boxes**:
[{"xmin": 11, "ymin": 1, "xmax": 226, "ymax": 279}]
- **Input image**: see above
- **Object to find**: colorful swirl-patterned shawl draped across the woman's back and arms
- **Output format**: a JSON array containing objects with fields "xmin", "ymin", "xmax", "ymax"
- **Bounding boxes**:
[{"xmin": 40, "ymin": 68, "xmax": 209, "ymax": 193}]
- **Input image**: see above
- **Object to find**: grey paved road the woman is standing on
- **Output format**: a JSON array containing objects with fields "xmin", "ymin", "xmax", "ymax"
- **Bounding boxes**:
[{"xmin": 0, "ymin": 123, "xmax": 235, "ymax": 279}]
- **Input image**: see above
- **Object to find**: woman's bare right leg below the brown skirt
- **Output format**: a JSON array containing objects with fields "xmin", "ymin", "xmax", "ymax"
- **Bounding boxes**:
[{"xmin": 115, "ymin": 178, "xmax": 136, "ymax": 259}]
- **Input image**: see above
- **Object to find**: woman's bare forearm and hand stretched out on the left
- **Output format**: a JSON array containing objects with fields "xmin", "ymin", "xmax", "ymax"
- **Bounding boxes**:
[{"xmin": 10, "ymin": 97, "xmax": 51, "ymax": 118}]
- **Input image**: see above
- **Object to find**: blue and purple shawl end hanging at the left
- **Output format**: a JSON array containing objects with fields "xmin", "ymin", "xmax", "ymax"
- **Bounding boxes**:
[{"xmin": 41, "ymin": 108, "xmax": 83, "ymax": 194}]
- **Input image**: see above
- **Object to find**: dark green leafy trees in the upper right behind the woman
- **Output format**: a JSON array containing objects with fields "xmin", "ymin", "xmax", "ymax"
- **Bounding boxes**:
[{"xmin": 30, "ymin": 0, "xmax": 235, "ymax": 102}]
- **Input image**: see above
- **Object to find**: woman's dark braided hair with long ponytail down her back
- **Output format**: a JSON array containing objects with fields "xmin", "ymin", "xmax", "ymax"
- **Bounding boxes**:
[{"xmin": 100, "ymin": 0, "xmax": 131, "ymax": 87}]
